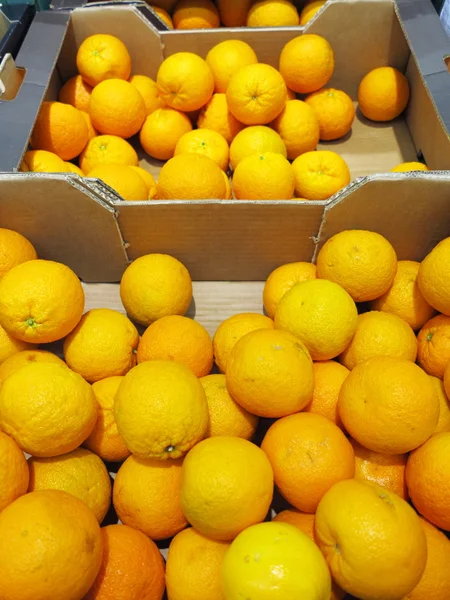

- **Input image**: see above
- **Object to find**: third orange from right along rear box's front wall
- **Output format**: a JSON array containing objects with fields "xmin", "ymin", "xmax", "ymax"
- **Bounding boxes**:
[{"xmin": 157, "ymin": 154, "xmax": 227, "ymax": 200}]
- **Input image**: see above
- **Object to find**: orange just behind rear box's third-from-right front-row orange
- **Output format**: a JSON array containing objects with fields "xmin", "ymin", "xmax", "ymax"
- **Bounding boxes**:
[{"xmin": 175, "ymin": 129, "xmax": 229, "ymax": 171}]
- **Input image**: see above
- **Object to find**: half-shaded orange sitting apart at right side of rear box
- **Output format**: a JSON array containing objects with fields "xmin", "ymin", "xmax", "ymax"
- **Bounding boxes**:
[{"xmin": 358, "ymin": 67, "xmax": 409, "ymax": 121}]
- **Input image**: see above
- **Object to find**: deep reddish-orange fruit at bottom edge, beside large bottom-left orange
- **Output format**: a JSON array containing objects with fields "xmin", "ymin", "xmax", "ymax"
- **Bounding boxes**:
[{"xmin": 84, "ymin": 525, "xmax": 165, "ymax": 600}]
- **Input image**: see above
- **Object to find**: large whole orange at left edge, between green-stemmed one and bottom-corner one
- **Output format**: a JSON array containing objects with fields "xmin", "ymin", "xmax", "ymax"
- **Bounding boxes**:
[{"xmin": 0, "ymin": 362, "xmax": 97, "ymax": 458}]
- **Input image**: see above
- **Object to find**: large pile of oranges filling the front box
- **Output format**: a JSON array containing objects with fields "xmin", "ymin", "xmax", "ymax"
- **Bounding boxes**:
[{"xmin": 0, "ymin": 229, "xmax": 450, "ymax": 600}]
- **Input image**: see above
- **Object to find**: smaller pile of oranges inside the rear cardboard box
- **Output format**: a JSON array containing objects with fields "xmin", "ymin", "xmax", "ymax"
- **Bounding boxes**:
[{"xmin": 22, "ymin": 24, "xmax": 427, "ymax": 201}]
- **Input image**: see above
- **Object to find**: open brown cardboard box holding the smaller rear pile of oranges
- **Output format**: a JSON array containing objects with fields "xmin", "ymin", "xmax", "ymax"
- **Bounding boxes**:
[{"xmin": 0, "ymin": 0, "xmax": 450, "ymax": 290}]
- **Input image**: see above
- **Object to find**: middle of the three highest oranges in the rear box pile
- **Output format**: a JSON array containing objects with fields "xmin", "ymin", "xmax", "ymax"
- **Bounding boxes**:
[{"xmin": 206, "ymin": 40, "xmax": 258, "ymax": 93}]
